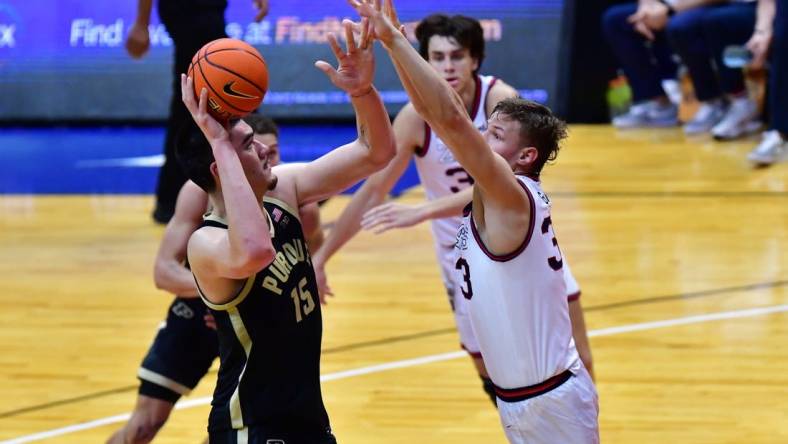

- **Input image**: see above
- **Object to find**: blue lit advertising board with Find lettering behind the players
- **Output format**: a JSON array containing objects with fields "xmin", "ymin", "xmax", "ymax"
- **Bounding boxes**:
[{"xmin": 0, "ymin": 0, "xmax": 563, "ymax": 121}]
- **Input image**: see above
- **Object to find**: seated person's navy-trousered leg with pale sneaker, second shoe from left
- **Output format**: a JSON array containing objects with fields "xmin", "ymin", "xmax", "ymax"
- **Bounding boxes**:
[{"xmin": 666, "ymin": 6, "xmax": 726, "ymax": 134}]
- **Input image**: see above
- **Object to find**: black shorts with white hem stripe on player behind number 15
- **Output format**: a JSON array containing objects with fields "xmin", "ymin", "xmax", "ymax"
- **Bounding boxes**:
[{"xmin": 137, "ymin": 298, "xmax": 219, "ymax": 403}]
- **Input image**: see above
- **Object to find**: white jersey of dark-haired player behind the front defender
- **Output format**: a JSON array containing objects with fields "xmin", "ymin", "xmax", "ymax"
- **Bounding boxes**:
[{"xmin": 416, "ymin": 76, "xmax": 496, "ymax": 247}]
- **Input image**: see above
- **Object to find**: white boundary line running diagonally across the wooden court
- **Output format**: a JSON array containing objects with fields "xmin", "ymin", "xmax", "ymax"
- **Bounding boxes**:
[{"xmin": 0, "ymin": 304, "xmax": 788, "ymax": 444}]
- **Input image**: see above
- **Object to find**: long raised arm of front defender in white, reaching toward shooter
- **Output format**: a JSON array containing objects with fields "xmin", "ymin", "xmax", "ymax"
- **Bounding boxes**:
[{"xmin": 348, "ymin": 0, "xmax": 529, "ymax": 214}]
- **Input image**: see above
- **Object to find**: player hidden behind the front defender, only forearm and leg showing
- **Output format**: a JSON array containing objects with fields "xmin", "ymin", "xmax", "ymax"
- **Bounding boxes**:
[{"xmin": 361, "ymin": 187, "xmax": 594, "ymax": 380}]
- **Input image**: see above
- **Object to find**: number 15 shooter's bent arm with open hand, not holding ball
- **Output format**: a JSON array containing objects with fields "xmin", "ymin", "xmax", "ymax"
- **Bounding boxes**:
[{"xmin": 296, "ymin": 21, "xmax": 396, "ymax": 204}]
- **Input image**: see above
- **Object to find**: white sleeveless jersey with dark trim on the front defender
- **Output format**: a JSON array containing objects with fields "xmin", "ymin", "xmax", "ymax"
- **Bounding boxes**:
[{"xmin": 455, "ymin": 176, "xmax": 581, "ymax": 388}]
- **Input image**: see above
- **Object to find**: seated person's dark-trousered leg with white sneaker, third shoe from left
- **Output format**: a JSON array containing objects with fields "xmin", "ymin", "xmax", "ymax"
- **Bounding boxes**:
[{"xmin": 703, "ymin": 3, "xmax": 761, "ymax": 140}]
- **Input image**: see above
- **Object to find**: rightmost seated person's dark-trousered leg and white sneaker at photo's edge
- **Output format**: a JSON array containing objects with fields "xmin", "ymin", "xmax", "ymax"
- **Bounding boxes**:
[{"xmin": 747, "ymin": 1, "xmax": 788, "ymax": 165}]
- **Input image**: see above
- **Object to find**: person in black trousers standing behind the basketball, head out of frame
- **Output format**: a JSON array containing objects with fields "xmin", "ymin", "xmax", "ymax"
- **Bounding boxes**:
[{"xmin": 126, "ymin": 0, "xmax": 268, "ymax": 224}]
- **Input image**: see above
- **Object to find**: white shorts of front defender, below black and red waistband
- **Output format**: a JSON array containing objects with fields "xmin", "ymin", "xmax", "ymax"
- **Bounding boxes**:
[{"xmin": 498, "ymin": 366, "xmax": 599, "ymax": 444}]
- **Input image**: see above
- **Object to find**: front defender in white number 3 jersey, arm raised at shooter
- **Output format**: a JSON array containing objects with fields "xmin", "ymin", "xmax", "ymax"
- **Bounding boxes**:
[{"xmin": 348, "ymin": 0, "xmax": 599, "ymax": 443}]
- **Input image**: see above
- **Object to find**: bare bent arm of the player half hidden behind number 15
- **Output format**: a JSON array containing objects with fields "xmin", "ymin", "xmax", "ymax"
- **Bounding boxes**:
[{"xmin": 153, "ymin": 181, "xmax": 208, "ymax": 297}]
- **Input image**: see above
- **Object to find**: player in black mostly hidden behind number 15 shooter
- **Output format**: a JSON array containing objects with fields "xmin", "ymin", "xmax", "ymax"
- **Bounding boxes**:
[{"xmin": 107, "ymin": 114, "xmax": 323, "ymax": 444}]
